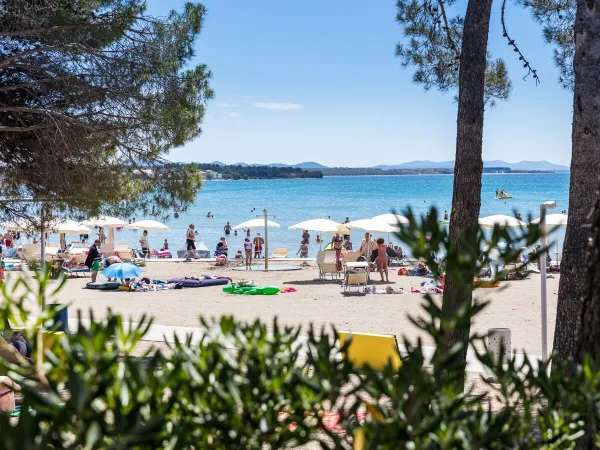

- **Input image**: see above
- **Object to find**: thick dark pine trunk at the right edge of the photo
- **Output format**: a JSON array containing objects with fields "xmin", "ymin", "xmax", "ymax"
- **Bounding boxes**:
[{"xmin": 552, "ymin": 0, "xmax": 600, "ymax": 370}]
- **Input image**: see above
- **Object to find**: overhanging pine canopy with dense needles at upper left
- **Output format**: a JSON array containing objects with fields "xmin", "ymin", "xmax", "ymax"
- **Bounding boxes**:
[{"xmin": 0, "ymin": 0, "xmax": 212, "ymax": 220}]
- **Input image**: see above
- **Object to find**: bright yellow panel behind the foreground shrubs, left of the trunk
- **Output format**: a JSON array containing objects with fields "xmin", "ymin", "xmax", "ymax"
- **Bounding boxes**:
[{"xmin": 338, "ymin": 331, "xmax": 402, "ymax": 370}]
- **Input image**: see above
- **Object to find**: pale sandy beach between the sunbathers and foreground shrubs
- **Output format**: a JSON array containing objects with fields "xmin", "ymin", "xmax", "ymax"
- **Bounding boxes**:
[{"xmin": 45, "ymin": 261, "xmax": 558, "ymax": 355}]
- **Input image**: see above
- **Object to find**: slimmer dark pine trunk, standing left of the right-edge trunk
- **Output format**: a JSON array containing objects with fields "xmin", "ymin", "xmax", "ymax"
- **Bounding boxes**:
[{"xmin": 443, "ymin": 0, "xmax": 492, "ymax": 382}]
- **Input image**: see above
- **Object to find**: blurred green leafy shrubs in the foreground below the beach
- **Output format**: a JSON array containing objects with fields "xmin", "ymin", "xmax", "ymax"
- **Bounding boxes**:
[{"xmin": 0, "ymin": 210, "xmax": 600, "ymax": 450}]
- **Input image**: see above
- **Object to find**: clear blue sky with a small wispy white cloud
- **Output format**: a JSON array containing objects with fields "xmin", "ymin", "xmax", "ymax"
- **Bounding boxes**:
[{"xmin": 148, "ymin": 0, "xmax": 572, "ymax": 167}]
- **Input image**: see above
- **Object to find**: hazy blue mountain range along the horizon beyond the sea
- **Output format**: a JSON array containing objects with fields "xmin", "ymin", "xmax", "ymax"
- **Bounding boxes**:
[{"xmin": 211, "ymin": 160, "xmax": 569, "ymax": 172}]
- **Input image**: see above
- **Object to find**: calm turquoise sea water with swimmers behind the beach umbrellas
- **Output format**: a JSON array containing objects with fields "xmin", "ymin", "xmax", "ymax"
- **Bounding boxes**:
[{"xmin": 61, "ymin": 173, "xmax": 569, "ymax": 256}]
